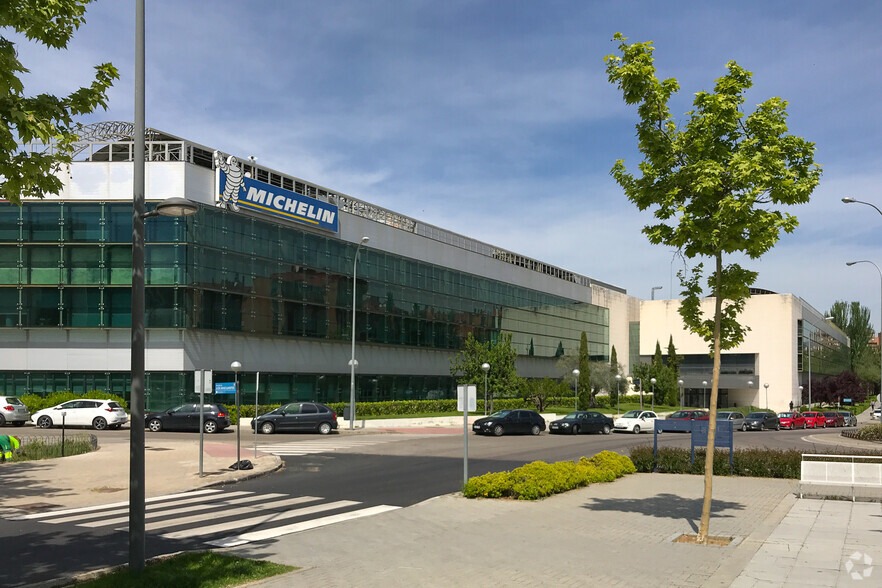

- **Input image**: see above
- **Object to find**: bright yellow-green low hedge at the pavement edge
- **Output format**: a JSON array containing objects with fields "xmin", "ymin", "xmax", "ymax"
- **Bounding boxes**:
[{"xmin": 462, "ymin": 451, "xmax": 636, "ymax": 500}]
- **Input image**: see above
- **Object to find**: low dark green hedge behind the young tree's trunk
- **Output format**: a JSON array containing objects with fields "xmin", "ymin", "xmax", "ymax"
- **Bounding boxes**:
[{"xmin": 630, "ymin": 445, "xmax": 880, "ymax": 480}]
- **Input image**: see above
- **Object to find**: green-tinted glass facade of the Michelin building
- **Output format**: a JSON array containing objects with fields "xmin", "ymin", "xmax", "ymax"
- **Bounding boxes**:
[{"xmin": 0, "ymin": 202, "xmax": 609, "ymax": 404}]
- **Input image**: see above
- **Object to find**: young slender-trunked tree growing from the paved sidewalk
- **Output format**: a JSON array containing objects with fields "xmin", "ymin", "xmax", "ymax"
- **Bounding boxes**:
[{"xmin": 604, "ymin": 33, "xmax": 821, "ymax": 543}]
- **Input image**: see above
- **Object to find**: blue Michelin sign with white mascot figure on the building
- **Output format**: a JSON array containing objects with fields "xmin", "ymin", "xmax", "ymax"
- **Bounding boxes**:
[{"xmin": 214, "ymin": 151, "xmax": 338, "ymax": 233}]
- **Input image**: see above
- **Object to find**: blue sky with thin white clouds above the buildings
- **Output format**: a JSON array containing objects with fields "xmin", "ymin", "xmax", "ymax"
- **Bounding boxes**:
[{"xmin": 10, "ymin": 0, "xmax": 882, "ymax": 330}]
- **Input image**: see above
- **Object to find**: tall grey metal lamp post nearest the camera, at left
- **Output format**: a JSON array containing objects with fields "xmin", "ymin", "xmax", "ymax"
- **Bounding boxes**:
[{"xmin": 129, "ymin": 0, "xmax": 199, "ymax": 573}]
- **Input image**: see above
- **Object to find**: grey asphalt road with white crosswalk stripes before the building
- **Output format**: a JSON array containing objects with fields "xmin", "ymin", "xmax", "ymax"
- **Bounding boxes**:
[{"xmin": 0, "ymin": 422, "xmax": 864, "ymax": 585}]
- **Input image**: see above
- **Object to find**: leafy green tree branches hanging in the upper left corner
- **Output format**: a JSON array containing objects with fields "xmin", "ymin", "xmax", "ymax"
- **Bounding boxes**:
[{"xmin": 0, "ymin": 0, "xmax": 119, "ymax": 205}]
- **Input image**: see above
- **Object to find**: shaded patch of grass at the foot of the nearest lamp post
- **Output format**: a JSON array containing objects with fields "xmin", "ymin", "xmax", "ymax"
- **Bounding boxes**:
[{"xmin": 77, "ymin": 551, "xmax": 298, "ymax": 588}]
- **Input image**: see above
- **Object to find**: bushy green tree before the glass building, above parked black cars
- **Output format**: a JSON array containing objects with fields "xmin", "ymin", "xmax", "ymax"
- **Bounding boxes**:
[{"xmin": 450, "ymin": 333, "xmax": 521, "ymax": 406}]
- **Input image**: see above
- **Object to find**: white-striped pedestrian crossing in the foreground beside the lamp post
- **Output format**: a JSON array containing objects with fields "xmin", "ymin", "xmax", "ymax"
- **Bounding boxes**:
[{"xmin": 11, "ymin": 489, "xmax": 400, "ymax": 547}]
